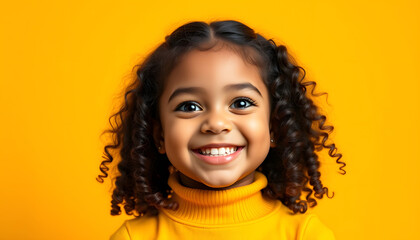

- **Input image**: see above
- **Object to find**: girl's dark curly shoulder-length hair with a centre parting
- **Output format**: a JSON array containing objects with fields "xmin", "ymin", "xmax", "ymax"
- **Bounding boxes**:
[{"xmin": 96, "ymin": 20, "xmax": 346, "ymax": 217}]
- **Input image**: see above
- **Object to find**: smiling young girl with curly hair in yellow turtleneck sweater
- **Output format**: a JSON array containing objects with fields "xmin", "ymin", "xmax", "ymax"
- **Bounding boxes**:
[{"xmin": 98, "ymin": 21, "xmax": 345, "ymax": 240}]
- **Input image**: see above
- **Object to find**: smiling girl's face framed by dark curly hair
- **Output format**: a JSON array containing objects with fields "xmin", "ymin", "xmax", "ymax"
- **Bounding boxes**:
[{"xmin": 159, "ymin": 45, "xmax": 270, "ymax": 188}]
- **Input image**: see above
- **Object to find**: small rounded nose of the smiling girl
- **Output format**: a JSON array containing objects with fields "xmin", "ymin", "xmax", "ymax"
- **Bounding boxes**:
[{"xmin": 201, "ymin": 111, "xmax": 232, "ymax": 134}]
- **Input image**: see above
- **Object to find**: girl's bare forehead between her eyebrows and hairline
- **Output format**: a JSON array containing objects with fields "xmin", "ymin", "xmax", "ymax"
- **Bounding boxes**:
[{"xmin": 164, "ymin": 47, "xmax": 265, "ymax": 92}]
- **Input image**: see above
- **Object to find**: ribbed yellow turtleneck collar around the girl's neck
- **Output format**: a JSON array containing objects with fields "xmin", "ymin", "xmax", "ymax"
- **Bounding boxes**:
[{"xmin": 163, "ymin": 172, "xmax": 278, "ymax": 226}]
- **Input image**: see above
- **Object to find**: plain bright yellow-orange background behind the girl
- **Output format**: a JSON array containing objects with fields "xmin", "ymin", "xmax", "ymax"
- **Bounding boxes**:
[{"xmin": 0, "ymin": 0, "xmax": 420, "ymax": 239}]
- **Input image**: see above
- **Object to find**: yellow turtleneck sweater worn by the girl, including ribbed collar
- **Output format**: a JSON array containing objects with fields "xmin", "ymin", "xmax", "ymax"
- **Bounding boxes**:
[{"xmin": 110, "ymin": 172, "xmax": 335, "ymax": 240}]
